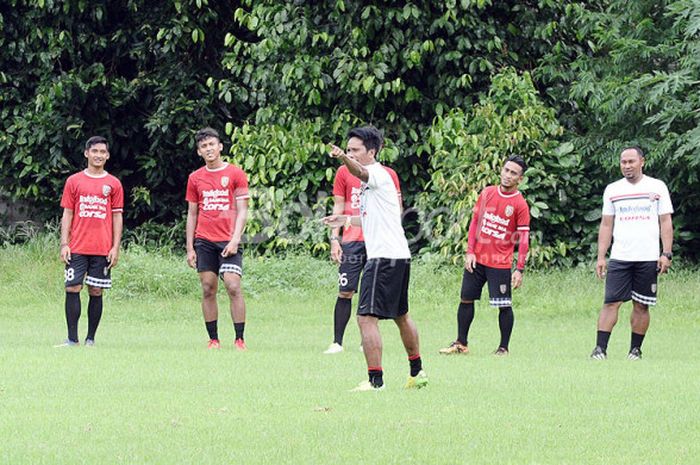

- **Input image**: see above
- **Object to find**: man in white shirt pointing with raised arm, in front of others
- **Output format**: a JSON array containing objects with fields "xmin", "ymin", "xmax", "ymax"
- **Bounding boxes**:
[{"xmin": 323, "ymin": 126, "xmax": 428, "ymax": 391}]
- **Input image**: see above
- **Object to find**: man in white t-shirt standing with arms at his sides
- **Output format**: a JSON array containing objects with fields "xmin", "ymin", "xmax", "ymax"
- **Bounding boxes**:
[{"xmin": 591, "ymin": 147, "xmax": 673, "ymax": 360}]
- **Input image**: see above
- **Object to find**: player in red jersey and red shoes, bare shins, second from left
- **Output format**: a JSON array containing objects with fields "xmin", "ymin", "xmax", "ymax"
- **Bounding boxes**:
[{"xmin": 185, "ymin": 128, "xmax": 250, "ymax": 350}]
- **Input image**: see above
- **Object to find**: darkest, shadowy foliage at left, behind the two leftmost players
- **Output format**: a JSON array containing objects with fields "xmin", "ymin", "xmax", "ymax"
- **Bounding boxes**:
[{"xmin": 0, "ymin": 0, "xmax": 241, "ymax": 225}]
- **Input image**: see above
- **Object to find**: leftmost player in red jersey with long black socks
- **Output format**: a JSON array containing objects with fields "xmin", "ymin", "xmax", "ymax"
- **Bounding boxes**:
[{"xmin": 57, "ymin": 136, "xmax": 124, "ymax": 347}]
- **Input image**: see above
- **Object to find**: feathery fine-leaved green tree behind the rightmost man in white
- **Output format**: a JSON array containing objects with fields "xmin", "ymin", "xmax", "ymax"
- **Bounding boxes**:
[{"xmin": 538, "ymin": 0, "xmax": 700, "ymax": 259}]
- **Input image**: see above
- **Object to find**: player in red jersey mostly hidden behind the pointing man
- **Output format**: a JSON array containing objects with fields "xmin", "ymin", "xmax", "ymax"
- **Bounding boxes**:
[{"xmin": 324, "ymin": 161, "xmax": 401, "ymax": 354}]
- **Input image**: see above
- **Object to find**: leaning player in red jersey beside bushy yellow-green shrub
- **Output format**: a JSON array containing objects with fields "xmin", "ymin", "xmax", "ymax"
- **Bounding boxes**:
[{"xmin": 440, "ymin": 155, "xmax": 530, "ymax": 355}]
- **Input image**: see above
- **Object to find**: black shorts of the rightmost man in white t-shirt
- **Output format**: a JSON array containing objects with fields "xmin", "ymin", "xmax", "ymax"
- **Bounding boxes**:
[{"xmin": 605, "ymin": 260, "xmax": 658, "ymax": 305}]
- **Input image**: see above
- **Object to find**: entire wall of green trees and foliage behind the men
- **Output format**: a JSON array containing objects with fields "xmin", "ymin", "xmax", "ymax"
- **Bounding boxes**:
[{"xmin": 0, "ymin": 0, "xmax": 700, "ymax": 265}]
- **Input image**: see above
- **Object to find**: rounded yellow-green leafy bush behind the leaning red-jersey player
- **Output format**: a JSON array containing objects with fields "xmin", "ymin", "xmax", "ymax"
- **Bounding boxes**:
[{"xmin": 418, "ymin": 70, "xmax": 597, "ymax": 266}]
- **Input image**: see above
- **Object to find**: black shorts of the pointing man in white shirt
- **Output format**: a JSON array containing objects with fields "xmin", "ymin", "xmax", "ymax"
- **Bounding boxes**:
[{"xmin": 357, "ymin": 258, "xmax": 411, "ymax": 319}]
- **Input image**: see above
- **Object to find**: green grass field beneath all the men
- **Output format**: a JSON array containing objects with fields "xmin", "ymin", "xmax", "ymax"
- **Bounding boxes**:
[{"xmin": 0, "ymin": 238, "xmax": 700, "ymax": 465}]
